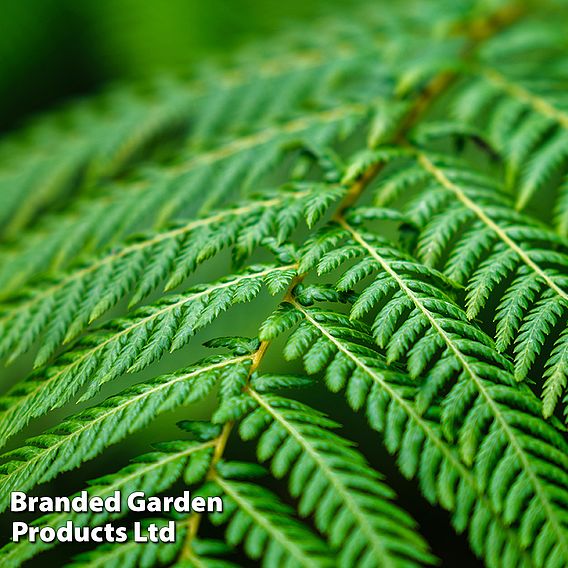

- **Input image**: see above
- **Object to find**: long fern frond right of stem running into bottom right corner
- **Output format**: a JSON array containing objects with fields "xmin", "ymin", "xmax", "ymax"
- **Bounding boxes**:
[{"xmin": 296, "ymin": 210, "xmax": 568, "ymax": 561}]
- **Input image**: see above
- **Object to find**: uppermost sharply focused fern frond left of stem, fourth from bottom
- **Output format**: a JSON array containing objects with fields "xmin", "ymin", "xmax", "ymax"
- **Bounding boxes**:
[{"xmin": 0, "ymin": 183, "xmax": 343, "ymax": 367}]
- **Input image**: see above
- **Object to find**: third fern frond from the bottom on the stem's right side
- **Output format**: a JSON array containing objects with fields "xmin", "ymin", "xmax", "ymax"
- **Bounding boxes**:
[{"xmin": 261, "ymin": 287, "xmax": 538, "ymax": 567}]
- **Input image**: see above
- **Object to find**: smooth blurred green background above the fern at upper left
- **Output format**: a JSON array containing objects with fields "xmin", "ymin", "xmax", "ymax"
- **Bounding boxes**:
[{"xmin": 0, "ymin": 0, "xmax": 356, "ymax": 132}]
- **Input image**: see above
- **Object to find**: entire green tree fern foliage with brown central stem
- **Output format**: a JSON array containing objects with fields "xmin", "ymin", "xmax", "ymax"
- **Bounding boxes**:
[{"xmin": 0, "ymin": 0, "xmax": 568, "ymax": 568}]
